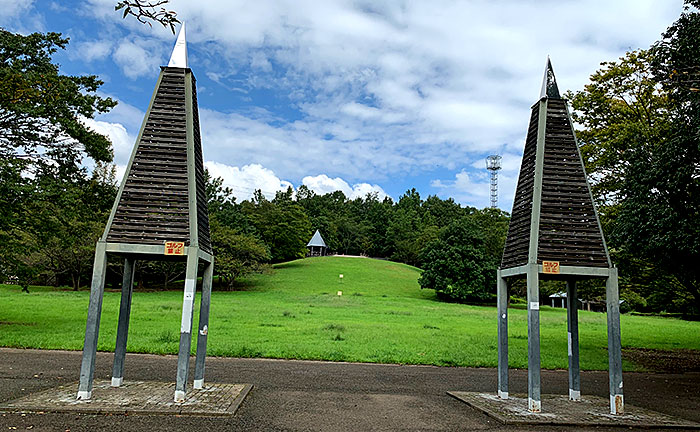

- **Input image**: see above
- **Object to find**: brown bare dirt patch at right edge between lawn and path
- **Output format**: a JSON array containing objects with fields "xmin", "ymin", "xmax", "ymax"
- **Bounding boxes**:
[{"xmin": 622, "ymin": 348, "xmax": 700, "ymax": 373}]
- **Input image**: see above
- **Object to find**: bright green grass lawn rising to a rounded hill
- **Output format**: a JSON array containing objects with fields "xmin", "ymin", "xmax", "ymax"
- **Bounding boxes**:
[{"xmin": 0, "ymin": 257, "xmax": 700, "ymax": 370}]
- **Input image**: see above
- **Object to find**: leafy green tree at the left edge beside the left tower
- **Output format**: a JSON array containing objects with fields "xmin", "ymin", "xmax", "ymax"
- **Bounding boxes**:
[{"xmin": 0, "ymin": 29, "xmax": 116, "ymax": 286}]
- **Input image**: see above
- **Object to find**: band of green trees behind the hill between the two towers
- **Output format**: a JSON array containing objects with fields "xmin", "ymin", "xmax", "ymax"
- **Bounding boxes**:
[{"xmin": 208, "ymin": 179, "xmax": 510, "ymax": 301}]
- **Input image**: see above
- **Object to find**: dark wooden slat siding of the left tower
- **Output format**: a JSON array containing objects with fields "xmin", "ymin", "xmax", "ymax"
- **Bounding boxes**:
[{"xmin": 107, "ymin": 68, "xmax": 211, "ymax": 252}]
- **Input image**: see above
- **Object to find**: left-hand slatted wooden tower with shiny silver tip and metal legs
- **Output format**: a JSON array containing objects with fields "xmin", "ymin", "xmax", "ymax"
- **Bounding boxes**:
[{"xmin": 78, "ymin": 24, "xmax": 214, "ymax": 402}]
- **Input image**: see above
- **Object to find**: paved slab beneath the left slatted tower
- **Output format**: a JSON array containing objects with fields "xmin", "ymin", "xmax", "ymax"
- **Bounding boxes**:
[{"xmin": 0, "ymin": 380, "xmax": 252, "ymax": 416}]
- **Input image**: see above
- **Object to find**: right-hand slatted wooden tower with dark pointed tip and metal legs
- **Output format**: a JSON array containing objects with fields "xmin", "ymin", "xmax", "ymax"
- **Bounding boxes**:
[{"xmin": 497, "ymin": 59, "xmax": 623, "ymax": 414}]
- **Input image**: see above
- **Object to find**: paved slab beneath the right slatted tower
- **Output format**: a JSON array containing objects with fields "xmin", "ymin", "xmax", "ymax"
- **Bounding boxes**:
[{"xmin": 447, "ymin": 391, "xmax": 700, "ymax": 429}]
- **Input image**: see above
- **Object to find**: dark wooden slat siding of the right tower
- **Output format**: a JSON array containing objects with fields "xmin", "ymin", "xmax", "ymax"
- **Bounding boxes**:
[{"xmin": 501, "ymin": 98, "xmax": 609, "ymax": 269}]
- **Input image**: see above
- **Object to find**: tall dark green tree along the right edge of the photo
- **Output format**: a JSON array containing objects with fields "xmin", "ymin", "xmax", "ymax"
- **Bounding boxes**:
[{"xmin": 614, "ymin": 0, "xmax": 700, "ymax": 314}]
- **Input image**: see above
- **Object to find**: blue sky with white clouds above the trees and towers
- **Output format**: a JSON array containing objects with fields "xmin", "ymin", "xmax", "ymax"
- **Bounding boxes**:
[{"xmin": 0, "ymin": 0, "xmax": 682, "ymax": 211}]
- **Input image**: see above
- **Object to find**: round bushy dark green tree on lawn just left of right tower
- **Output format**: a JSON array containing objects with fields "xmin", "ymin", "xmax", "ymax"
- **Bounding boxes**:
[{"xmin": 418, "ymin": 217, "xmax": 498, "ymax": 302}]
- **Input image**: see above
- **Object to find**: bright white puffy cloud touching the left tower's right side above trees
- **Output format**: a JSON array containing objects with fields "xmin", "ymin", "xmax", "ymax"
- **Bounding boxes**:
[{"xmin": 204, "ymin": 161, "xmax": 292, "ymax": 202}]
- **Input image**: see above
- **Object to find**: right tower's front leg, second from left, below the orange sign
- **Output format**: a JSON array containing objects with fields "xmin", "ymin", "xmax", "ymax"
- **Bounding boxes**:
[{"xmin": 527, "ymin": 264, "xmax": 542, "ymax": 412}]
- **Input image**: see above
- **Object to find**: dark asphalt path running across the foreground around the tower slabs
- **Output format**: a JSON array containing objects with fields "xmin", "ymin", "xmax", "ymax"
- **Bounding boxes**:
[{"xmin": 0, "ymin": 348, "xmax": 700, "ymax": 432}]
